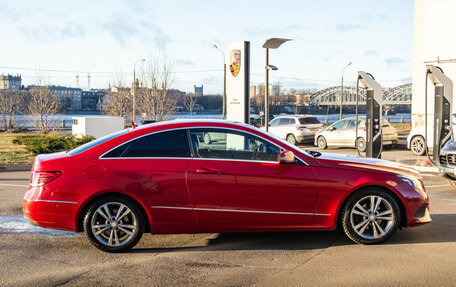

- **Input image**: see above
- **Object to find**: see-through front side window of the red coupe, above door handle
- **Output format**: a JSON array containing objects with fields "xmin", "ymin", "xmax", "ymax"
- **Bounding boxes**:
[{"xmin": 190, "ymin": 128, "xmax": 281, "ymax": 162}]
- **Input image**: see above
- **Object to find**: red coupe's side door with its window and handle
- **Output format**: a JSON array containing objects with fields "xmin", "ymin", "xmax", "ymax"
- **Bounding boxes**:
[{"xmin": 187, "ymin": 128, "xmax": 317, "ymax": 230}]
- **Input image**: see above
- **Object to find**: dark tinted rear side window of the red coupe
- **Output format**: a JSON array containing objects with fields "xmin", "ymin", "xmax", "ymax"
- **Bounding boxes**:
[{"xmin": 103, "ymin": 130, "xmax": 191, "ymax": 158}]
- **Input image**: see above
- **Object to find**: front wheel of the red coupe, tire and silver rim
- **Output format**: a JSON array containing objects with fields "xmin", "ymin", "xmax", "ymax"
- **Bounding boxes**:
[{"xmin": 341, "ymin": 188, "xmax": 401, "ymax": 244}]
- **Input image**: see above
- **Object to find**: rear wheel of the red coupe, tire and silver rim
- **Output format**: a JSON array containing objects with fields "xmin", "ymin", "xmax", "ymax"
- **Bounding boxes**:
[{"xmin": 84, "ymin": 196, "xmax": 145, "ymax": 252}]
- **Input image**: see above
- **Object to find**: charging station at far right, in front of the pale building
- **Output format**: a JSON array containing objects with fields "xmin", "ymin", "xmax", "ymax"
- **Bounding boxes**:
[{"xmin": 424, "ymin": 65, "xmax": 453, "ymax": 165}]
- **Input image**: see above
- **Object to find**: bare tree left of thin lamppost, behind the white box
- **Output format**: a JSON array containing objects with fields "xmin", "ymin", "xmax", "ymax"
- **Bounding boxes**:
[{"xmin": 101, "ymin": 77, "xmax": 133, "ymax": 122}]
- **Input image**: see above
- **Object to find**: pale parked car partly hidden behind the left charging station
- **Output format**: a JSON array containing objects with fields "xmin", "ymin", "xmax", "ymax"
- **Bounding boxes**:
[{"xmin": 314, "ymin": 117, "xmax": 399, "ymax": 151}]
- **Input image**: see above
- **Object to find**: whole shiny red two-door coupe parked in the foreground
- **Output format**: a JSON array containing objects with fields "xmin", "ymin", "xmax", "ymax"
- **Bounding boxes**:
[{"xmin": 23, "ymin": 120, "xmax": 431, "ymax": 252}]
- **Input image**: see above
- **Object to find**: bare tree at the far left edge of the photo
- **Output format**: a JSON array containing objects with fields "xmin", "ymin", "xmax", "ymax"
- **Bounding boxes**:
[{"xmin": 0, "ymin": 90, "xmax": 24, "ymax": 131}]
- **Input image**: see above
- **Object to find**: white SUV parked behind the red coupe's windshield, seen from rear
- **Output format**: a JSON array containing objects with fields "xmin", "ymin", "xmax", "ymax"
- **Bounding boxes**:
[{"xmin": 269, "ymin": 115, "xmax": 323, "ymax": 145}]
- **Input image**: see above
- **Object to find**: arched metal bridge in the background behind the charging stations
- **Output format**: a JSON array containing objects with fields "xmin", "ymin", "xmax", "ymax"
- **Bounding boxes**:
[{"xmin": 310, "ymin": 83, "xmax": 412, "ymax": 106}]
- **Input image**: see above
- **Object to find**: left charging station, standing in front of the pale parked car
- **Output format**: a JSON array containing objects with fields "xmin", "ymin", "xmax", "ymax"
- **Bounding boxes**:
[{"xmin": 356, "ymin": 71, "xmax": 383, "ymax": 158}]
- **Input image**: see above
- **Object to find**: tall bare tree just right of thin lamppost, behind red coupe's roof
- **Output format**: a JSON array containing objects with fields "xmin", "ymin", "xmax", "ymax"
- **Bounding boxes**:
[{"xmin": 136, "ymin": 49, "xmax": 177, "ymax": 121}]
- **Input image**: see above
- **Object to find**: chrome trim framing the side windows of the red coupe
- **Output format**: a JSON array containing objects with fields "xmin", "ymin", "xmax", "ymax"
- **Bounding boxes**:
[{"xmin": 98, "ymin": 125, "xmax": 309, "ymax": 166}]
